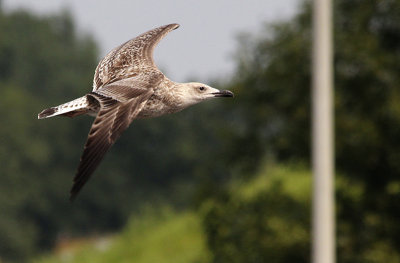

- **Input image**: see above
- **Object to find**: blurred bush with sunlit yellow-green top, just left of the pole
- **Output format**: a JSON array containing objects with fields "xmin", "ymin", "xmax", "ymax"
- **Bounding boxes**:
[{"xmin": 202, "ymin": 168, "xmax": 310, "ymax": 263}]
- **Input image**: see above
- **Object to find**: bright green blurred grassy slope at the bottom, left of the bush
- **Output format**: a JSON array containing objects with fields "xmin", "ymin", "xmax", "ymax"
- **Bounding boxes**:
[{"xmin": 34, "ymin": 209, "xmax": 209, "ymax": 263}]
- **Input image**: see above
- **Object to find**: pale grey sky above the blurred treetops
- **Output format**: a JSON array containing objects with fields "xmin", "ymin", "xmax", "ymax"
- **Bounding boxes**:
[{"xmin": 3, "ymin": 0, "xmax": 301, "ymax": 82}]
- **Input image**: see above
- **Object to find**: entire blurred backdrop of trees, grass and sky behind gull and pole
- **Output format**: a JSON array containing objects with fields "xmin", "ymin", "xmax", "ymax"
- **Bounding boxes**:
[{"xmin": 0, "ymin": 0, "xmax": 400, "ymax": 263}]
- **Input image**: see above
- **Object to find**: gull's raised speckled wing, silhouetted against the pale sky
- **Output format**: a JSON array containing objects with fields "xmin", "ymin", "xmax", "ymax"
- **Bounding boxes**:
[{"xmin": 93, "ymin": 24, "xmax": 179, "ymax": 91}]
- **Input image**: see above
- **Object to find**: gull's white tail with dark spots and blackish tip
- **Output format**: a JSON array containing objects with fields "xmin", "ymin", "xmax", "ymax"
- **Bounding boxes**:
[{"xmin": 38, "ymin": 96, "xmax": 90, "ymax": 119}]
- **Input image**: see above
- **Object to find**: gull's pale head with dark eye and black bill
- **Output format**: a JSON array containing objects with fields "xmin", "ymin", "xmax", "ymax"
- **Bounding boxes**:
[{"xmin": 179, "ymin": 82, "xmax": 233, "ymax": 107}]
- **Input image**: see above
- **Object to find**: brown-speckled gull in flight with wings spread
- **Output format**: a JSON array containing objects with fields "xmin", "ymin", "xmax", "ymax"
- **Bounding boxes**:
[{"xmin": 38, "ymin": 24, "xmax": 233, "ymax": 201}]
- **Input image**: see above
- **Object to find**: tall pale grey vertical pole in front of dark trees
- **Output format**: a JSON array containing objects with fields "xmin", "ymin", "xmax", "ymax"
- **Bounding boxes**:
[{"xmin": 312, "ymin": 0, "xmax": 335, "ymax": 263}]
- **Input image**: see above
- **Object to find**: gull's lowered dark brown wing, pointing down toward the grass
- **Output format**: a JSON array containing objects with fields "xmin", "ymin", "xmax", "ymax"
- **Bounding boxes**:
[{"xmin": 70, "ymin": 77, "xmax": 153, "ymax": 201}]
